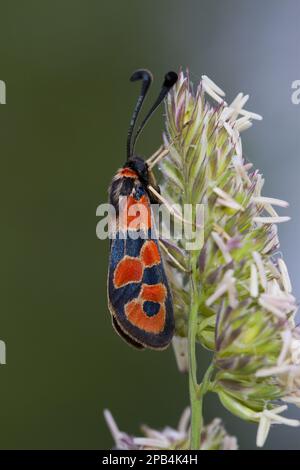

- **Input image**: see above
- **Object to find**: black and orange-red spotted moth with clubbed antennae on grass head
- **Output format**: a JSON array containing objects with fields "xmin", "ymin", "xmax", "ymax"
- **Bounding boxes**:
[{"xmin": 108, "ymin": 70, "xmax": 178, "ymax": 349}]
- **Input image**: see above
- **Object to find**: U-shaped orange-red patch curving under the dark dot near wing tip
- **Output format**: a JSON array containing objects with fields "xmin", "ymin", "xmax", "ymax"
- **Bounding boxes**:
[{"xmin": 125, "ymin": 300, "xmax": 166, "ymax": 334}]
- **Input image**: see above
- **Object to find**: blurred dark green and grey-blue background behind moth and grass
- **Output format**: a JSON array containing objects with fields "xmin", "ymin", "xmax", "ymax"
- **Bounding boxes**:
[{"xmin": 0, "ymin": 0, "xmax": 300, "ymax": 449}]
